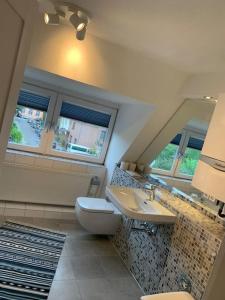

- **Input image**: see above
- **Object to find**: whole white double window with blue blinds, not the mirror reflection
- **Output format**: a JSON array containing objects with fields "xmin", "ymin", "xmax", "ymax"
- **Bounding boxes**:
[{"xmin": 9, "ymin": 85, "xmax": 116, "ymax": 163}]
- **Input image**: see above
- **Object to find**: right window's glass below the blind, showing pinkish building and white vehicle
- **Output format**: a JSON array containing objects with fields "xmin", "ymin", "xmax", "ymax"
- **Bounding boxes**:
[{"xmin": 52, "ymin": 117, "xmax": 108, "ymax": 157}]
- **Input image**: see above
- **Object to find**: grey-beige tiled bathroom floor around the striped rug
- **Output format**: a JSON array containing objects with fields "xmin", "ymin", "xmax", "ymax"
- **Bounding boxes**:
[{"xmin": 0, "ymin": 217, "xmax": 142, "ymax": 300}]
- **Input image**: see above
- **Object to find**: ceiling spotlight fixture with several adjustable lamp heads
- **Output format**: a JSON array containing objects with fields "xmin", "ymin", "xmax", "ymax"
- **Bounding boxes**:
[{"xmin": 44, "ymin": 0, "xmax": 90, "ymax": 41}]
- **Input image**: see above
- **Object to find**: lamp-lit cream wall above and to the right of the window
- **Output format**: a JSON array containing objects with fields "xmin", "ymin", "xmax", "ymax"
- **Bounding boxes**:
[{"xmin": 28, "ymin": 14, "xmax": 188, "ymax": 175}]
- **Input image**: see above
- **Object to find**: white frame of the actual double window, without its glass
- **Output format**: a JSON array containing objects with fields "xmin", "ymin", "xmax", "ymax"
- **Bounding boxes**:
[{"xmin": 7, "ymin": 83, "xmax": 117, "ymax": 164}]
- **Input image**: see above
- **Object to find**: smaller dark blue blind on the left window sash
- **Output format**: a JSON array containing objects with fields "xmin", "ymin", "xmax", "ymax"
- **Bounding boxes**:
[{"xmin": 17, "ymin": 90, "xmax": 50, "ymax": 111}]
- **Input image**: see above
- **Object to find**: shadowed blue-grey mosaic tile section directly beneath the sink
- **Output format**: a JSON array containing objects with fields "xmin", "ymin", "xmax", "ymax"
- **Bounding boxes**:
[{"xmin": 113, "ymin": 217, "xmax": 173, "ymax": 294}]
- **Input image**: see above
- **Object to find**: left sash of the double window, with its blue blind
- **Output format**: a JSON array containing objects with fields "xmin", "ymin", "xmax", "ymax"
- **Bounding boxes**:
[{"xmin": 9, "ymin": 84, "xmax": 55, "ymax": 152}]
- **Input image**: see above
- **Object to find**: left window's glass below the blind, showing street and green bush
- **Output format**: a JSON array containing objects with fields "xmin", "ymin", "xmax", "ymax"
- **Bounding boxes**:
[{"xmin": 9, "ymin": 105, "xmax": 46, "ymax": 147}]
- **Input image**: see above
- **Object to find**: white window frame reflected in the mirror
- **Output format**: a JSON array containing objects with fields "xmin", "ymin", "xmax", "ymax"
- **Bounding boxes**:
[{"xmin": 152, "ymin": 128, "xmax": 206, "ymax": 180}]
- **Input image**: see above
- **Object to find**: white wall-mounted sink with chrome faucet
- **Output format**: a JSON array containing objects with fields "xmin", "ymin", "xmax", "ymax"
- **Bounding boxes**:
[{"xmin": 106, "ymin": 185, "xmax": 176, "ymax": 224}]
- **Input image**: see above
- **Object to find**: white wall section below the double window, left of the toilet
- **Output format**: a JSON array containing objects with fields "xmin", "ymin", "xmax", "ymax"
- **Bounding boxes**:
[{"xmin": 0, "ymin": 151, "xmax": 106, "ymax": 206}]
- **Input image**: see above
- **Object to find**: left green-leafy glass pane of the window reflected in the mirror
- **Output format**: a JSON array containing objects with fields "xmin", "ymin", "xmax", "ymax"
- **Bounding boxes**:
[{"xmin": 151, "ymin": 144, "xmax": 179, "ymax": 171}]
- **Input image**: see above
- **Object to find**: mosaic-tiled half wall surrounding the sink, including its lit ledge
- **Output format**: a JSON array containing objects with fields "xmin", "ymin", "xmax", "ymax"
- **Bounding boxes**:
[{"xmin": 111, "ymin": 168, "xmax": 225, "ymax": 300}]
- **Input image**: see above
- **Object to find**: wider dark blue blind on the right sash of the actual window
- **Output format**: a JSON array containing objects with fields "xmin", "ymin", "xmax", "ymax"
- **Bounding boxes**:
[{"xmin": 60, "ymin": 102, "xmax": 111, "ymax": 128}]
